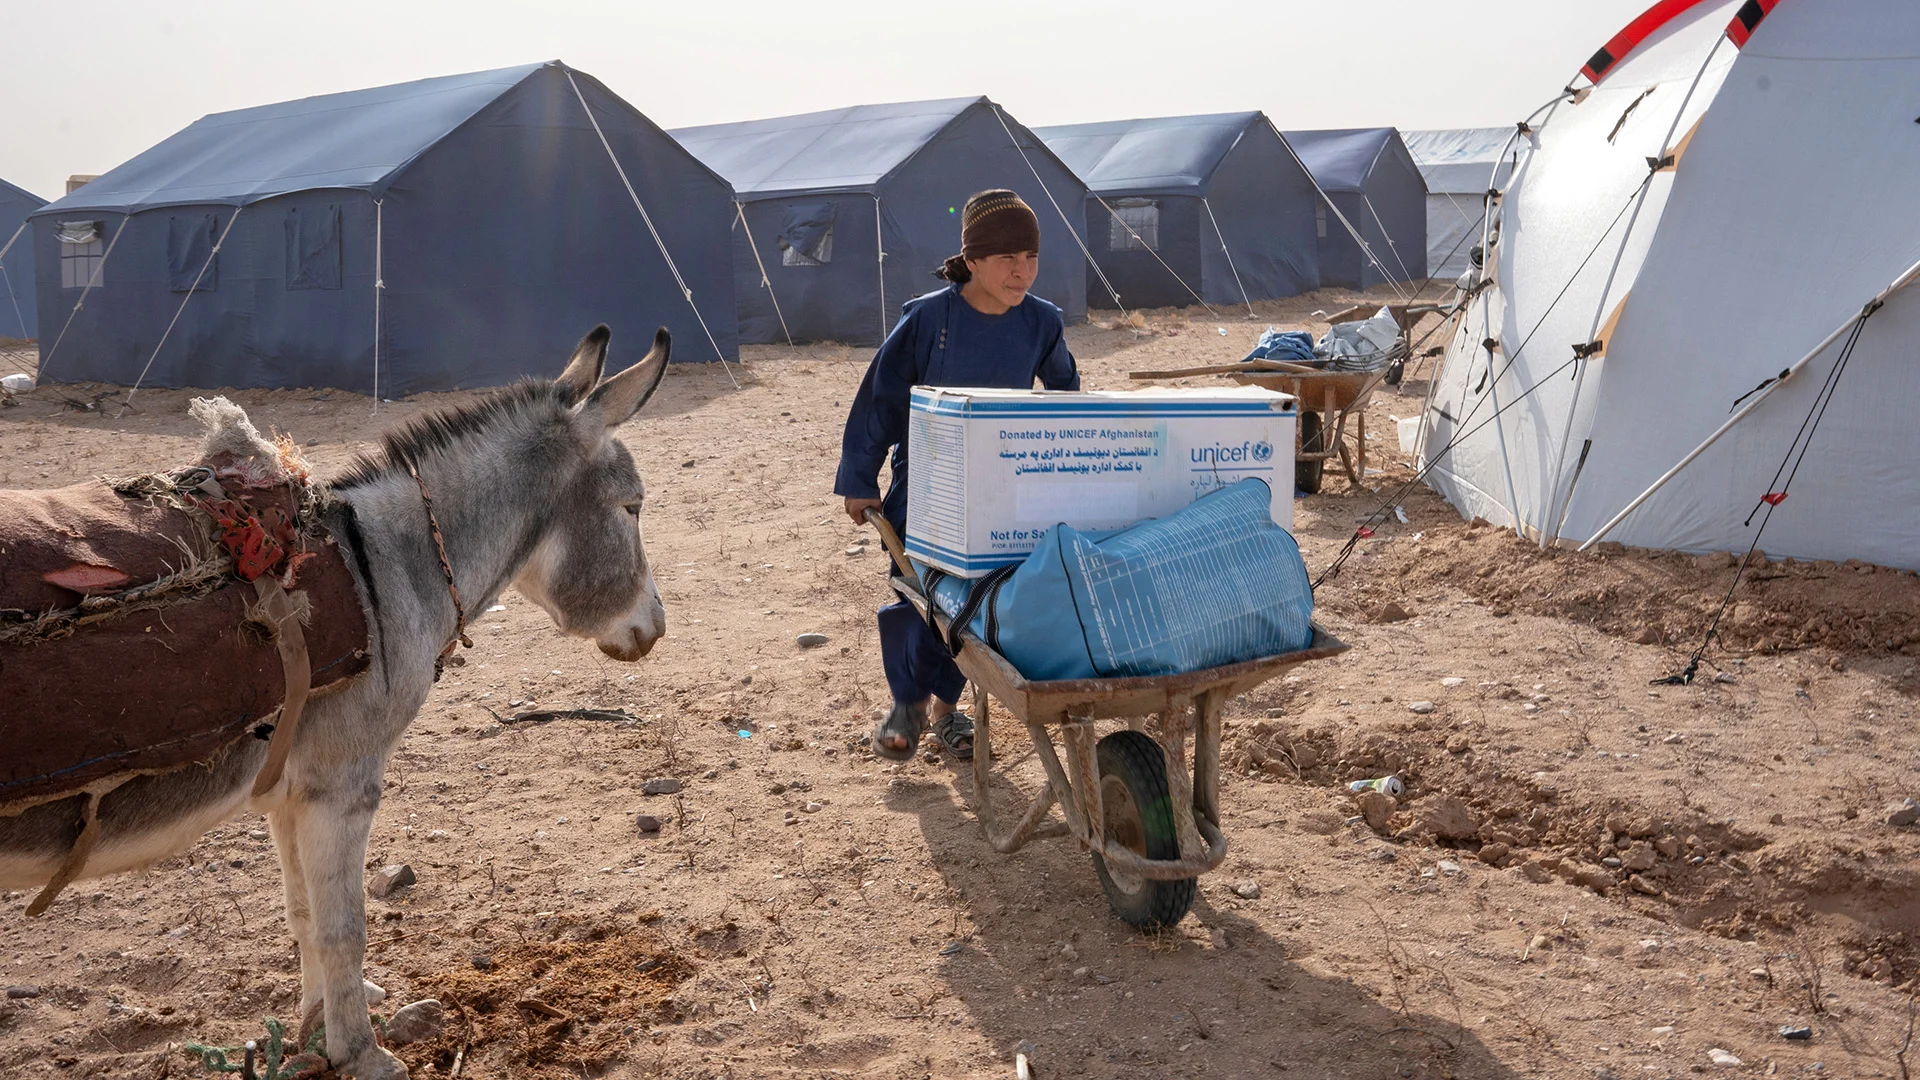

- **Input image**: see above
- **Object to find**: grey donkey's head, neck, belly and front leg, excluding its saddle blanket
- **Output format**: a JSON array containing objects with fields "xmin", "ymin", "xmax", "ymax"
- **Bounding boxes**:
[{"xmin": 0, "ymin": 327, "xmax": 670, "ymax": 1080}]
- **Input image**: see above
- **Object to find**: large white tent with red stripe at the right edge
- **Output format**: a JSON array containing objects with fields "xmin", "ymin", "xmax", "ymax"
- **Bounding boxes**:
[{"xmin": 1421, "ymin": 0, "xmax": 1920, "ymax": 567}]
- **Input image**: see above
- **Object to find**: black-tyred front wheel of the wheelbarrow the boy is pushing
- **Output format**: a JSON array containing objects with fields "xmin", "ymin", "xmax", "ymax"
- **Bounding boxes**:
[{"xmin": 1092, "ymin": 730, "xmax": 1200, "ymax": 932}]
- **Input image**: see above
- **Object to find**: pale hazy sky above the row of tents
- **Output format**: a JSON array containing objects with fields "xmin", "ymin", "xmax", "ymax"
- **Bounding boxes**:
[{"xmin": 0, "ymin": 0, "xmax": 1651, "ymax": 198}]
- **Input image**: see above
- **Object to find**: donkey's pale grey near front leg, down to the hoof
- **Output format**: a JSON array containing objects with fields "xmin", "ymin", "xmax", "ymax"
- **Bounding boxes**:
[{"xmin": 294, "ymin": 755, "xmax": 407, "ymax": 1080}]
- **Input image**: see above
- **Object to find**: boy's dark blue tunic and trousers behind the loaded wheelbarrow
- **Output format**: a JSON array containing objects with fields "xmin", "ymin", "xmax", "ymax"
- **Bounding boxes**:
[{"xmin": 833, "ymin": 286, "xmax": 1079, "ymax": 701}]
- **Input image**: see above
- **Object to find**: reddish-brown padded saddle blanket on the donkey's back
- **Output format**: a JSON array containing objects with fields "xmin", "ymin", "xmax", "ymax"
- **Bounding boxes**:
[{"xmin": 0, "ymin": 480, "xmax": 369, "ymax": 807}]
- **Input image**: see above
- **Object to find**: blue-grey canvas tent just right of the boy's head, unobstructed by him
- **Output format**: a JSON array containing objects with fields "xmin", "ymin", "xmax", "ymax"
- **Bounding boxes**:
[{"xmin": 1035, "ymin": 111, "xmax": 1319, "ymax": 307}]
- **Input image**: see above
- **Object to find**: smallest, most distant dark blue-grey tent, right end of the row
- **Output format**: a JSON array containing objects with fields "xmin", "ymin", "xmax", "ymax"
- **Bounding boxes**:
[{"xmin": 1286, "ymin": 127, "xmax": 1427, "ymax": 288}]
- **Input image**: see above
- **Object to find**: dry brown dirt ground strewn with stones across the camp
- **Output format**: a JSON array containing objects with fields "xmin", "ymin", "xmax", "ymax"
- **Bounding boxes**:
[{"xmin": 0, "ymin": 286, "xmax": 1920, "ymax": 1080}]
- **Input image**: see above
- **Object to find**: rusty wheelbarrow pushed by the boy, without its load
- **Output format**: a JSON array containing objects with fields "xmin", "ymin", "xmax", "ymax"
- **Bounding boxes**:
[{"xmin": 866, "ymin": 511, "xmax": 1348, "ymax": 932}]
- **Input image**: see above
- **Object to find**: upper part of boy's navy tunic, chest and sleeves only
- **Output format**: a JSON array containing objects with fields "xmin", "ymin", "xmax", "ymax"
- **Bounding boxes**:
[{"xmin": 833, "ymin": 286, "xmax": 1079, "ymax": 532}]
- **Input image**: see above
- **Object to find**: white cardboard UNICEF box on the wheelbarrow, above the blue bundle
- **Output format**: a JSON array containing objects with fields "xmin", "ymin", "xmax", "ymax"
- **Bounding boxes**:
[{"xmin": 906, "ymin": 386, "xmax": 1298, "ymax": 577}]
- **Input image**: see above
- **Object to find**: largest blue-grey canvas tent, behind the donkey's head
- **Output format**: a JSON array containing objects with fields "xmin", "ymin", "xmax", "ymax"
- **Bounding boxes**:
[{"xmin": 33, "ymin": 61, "xmax": 737, "ymax": 396}]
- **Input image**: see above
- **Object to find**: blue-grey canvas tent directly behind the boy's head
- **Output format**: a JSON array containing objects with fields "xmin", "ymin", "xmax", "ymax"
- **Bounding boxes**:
[{"xmin": 672, "ymin": 98, "xmax": 1087, "ymax": 346}]
